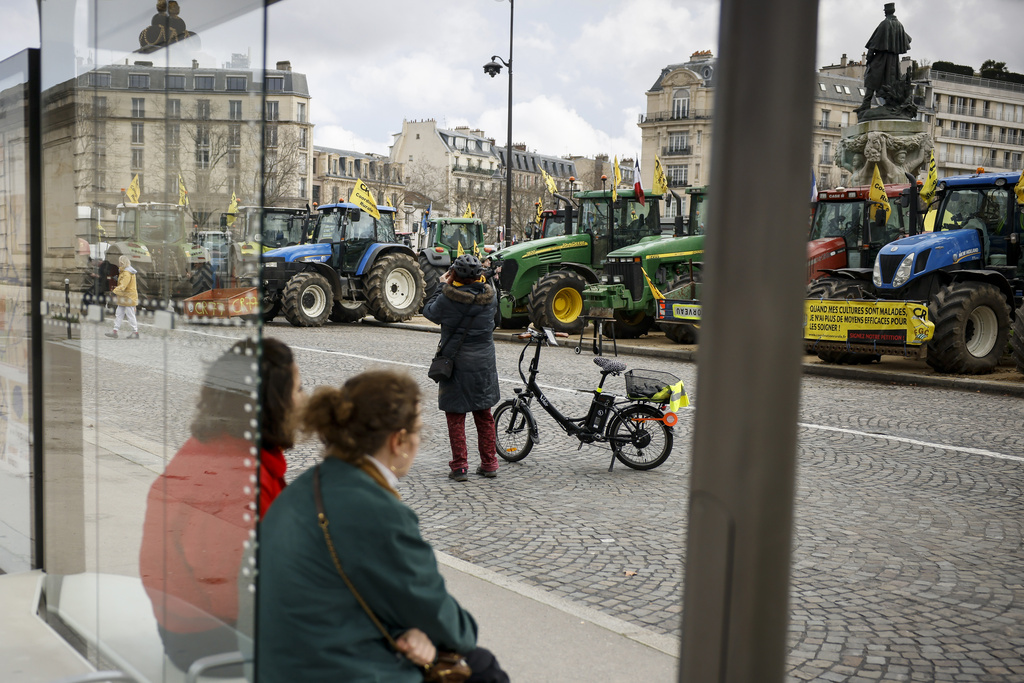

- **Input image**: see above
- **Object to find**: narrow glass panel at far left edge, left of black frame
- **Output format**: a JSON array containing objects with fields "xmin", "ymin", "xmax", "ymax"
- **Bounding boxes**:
[{"xmin": 0, "ymin": 52, "xmax": 34, "ymax": 572}]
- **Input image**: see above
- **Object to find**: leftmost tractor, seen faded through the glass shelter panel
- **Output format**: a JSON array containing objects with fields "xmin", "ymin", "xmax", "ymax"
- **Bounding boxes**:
[{"xmin": 96, "ymin": 202, "xmax": 213, "ymax": 301}]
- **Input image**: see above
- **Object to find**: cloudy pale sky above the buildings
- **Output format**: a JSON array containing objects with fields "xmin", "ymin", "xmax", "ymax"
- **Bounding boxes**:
[{"xmin": 0, "ymin": 0, "xmax": 1024, "ymax": 157}]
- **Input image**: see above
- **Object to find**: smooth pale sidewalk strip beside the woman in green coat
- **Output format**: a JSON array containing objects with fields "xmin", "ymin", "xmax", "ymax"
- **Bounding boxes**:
[{"xmin": 437, "ymin": 552, "xmax": 679, "ymax": 683}]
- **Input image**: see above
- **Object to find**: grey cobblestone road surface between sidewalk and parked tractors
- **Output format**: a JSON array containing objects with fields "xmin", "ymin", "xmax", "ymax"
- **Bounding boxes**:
[{"xmin": 75, "ymin": 323, "xmax": 1024, "ymax": 682}]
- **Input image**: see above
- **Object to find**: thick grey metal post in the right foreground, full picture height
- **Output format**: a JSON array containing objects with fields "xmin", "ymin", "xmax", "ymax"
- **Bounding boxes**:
[{"xmin": 679, "ymin": 0, "xmax": 818, "ymax": 683}]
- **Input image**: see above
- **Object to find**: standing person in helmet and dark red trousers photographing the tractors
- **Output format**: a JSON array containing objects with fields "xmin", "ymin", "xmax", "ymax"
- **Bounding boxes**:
[{"xmin": 423, "ymin": 254, "xmax": 501, "ymax": 481}]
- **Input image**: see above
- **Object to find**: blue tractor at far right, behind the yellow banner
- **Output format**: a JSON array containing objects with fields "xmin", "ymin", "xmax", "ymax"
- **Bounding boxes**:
[{"xmin": 818, "ymin": 172, "xmax": 1024, "ymax": 375}]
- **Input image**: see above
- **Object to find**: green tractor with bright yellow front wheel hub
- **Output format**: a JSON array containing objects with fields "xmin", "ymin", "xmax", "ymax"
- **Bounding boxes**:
[{"xmin": 492, "ymin": 189, "xmax": 662, "ymax": 334}]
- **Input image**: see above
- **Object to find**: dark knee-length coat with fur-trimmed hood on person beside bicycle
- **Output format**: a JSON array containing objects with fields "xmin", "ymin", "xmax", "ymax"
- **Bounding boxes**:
[{"xmin": 423, "ymin": 283, "xmax": 501, "ymax": 413}]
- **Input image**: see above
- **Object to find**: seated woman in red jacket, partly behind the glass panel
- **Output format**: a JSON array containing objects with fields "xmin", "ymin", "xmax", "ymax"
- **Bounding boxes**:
[{"xmin": 139, "ymin": 339, "xmax": 302, "ymax": 673}]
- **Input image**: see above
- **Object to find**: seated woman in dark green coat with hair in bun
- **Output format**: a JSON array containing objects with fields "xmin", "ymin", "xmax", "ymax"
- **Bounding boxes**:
[{"xmin": 257, "ymin": 371, "xmax": 509, "ymax": 683}]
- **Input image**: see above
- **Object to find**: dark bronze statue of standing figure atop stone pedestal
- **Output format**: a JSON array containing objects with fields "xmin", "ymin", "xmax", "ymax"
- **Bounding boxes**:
[{"xmin": 854, "ymin": 2, "xmax": 918, "ymax": 121}]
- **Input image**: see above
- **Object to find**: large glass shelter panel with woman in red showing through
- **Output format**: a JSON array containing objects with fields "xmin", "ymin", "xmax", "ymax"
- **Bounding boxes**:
[{"xmin": 42, "ymin": 0, "xmax": 268, "ymax": 681}]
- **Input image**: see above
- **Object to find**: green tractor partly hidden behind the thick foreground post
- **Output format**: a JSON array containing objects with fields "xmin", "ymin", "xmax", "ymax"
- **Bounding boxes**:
[{"xmin": 583, "ymin": 187, "xmax": 708, "ymax": 339}]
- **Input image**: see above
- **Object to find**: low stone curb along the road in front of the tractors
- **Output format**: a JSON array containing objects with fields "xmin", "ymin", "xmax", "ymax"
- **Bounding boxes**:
[{"xmin": 361, "ymin": 318, "xmax": 1024, "ymax": 397}]
